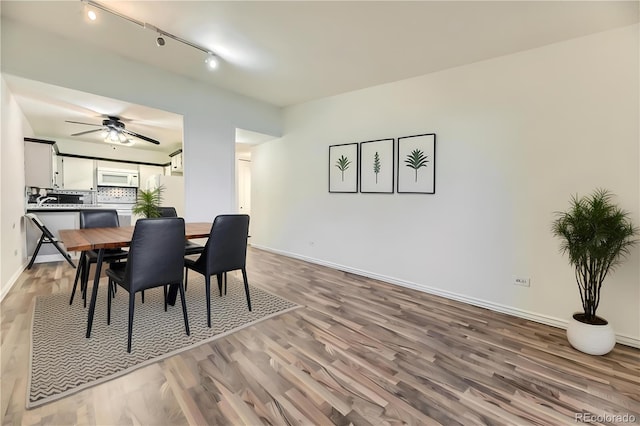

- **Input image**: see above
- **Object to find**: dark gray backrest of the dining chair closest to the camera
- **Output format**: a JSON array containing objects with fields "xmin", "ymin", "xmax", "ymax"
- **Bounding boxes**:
[{"xmin": 125, "ymin": 217, "xmax": 185, "ymax": 292}]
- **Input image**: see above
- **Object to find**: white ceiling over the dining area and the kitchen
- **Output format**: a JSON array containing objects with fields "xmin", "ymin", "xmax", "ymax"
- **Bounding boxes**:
[{"xmin": 0, "ymin": 0, "xmax": 640, "ymax": 154}]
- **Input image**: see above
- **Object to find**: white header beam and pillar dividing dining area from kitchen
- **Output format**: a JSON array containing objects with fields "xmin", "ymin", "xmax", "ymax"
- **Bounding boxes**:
[{"xmin": 2, "ymin": 17, "xmax": 282, "ymax": 221}]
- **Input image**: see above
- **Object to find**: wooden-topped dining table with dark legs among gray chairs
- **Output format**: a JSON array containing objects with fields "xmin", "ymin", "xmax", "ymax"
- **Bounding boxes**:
[{"xmin": 58, "ymin": 222, "xmax": 212, "ymax": 338}]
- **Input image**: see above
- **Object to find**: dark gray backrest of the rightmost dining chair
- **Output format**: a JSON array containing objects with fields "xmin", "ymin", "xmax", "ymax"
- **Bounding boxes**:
[{"xmin": 196, "ymin": 214, "xmax": 249, "ymax": 275}]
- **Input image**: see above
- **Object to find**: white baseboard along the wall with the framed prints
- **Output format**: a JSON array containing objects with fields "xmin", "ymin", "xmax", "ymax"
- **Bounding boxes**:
[{"xmin": 252, "ymin": 244, "xmax": 640, "ymax": 348}]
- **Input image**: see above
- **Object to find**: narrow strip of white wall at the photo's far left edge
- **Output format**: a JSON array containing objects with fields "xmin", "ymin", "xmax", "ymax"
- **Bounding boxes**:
[{"xmin": 0, "ymin": 78, "xmax": 33, "ymax": 299}]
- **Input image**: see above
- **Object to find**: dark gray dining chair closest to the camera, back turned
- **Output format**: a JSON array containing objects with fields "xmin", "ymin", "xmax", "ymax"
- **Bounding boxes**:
[{"xmin": 106, "ymin": 217, "xmax": 190, "ymax": 352}]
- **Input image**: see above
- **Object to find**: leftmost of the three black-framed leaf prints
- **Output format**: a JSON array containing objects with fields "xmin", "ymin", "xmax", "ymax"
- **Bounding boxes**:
[{"xmin": 329, "ymin": 143, "xmax": 358, "ymax": 192}]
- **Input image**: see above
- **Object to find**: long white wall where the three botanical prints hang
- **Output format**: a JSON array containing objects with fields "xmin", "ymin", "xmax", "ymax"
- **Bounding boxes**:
[{"xmin": 252, "ymin": 25, "xmax": 640, "ymax": 345}]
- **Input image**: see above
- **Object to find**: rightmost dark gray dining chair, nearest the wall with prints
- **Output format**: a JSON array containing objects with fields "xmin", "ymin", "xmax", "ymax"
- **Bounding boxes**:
[{"xmin": 184, "ymin": 214, "xmax": 251, "ymax": 327}]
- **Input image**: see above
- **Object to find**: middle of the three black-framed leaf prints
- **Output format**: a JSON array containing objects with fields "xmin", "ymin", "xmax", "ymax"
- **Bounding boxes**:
[{"xmin": 360, "ymin": 139, "xmax": 395, "ymax": 194}]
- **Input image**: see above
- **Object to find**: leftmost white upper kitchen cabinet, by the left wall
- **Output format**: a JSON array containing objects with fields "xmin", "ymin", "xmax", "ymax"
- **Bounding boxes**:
[{"xmin": 24, "ymin": 140, "xmax": 62, "ymax": 189}]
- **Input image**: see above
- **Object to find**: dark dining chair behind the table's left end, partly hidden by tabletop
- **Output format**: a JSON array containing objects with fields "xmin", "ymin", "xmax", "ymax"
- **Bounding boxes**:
[{"xmin": 69, "ymin": 209, "xmax": 127, "ymax": 307}]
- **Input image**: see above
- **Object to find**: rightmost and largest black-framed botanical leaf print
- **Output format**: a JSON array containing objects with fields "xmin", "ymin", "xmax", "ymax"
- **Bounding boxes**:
[{"xmin": 396, "ymin": 133, "xmax": 436, "ymax": 194}]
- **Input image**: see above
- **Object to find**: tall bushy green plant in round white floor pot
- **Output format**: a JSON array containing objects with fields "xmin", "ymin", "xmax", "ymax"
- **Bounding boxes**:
[{"xmin": 552, "ymin": 189, "xmax": 638, "ymax": 355}]
